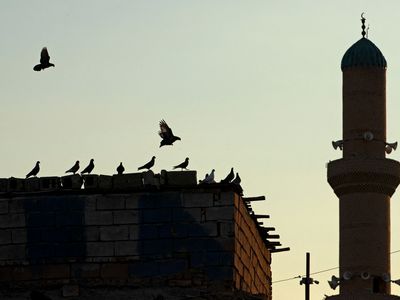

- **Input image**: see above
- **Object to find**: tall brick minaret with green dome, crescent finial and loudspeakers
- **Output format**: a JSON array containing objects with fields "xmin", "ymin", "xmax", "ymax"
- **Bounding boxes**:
[{"xmin": 328, "ymin": 17, "xmax": 400, "ymax": 300}]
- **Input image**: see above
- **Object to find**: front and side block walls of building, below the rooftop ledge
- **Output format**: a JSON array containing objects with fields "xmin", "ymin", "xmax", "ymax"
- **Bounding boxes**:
[{"xmin": 0, "ymin": 184, "xmax": 270, "ymax": 299}]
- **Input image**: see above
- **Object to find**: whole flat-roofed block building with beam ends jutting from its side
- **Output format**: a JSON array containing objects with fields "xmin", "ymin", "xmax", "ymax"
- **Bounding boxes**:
[{"xmin": 0, "ymin": 171, "xmax": 288, "ymax": 300}]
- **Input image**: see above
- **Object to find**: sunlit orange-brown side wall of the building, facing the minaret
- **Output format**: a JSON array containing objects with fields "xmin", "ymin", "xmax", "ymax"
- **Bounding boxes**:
[{"xmin": 234, "ymin": 195, "xmax": 272, "ymax": 299}]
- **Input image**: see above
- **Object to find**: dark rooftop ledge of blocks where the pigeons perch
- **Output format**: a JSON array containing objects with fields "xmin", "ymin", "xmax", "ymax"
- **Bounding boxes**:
[{"xmin": 0, "ymin": 170, "xmax": 243, "ymax": 197}]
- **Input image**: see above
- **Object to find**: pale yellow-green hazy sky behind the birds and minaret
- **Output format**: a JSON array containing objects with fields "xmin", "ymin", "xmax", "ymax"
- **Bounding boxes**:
[{"xmin": 0, "ymin": 0, "xmax": 400, "ymax": 300}]
